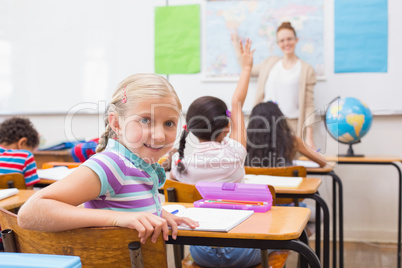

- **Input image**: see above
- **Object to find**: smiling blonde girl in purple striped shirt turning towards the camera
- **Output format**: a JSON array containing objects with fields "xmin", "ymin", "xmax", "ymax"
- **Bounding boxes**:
[{"xmin": 18, "ymin": 74, "xmax": 198, "ymax": 243}]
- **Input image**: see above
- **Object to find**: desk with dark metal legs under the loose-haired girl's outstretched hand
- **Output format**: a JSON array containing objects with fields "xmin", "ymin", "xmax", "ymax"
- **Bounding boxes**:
[{"xmin": 301, "ymin": 163, "xmax": 344, "ymax": 268}]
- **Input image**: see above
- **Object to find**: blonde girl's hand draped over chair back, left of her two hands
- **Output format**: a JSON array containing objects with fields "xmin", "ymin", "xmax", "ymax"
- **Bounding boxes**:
[{"xmin": 113, "ymin": 212, "xmax": 169, "ymax": 244}]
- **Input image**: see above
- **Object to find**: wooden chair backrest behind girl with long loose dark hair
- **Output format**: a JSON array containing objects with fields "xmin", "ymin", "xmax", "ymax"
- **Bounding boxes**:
[{"xmin": 244, "ymin": 166, "xmax": 307, "ymax": 177}]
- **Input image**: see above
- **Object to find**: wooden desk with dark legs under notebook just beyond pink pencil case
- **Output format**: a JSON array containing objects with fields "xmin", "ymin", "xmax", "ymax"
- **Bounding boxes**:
[{"xmin": 275, "ymin": 178, "xmax": 330, "ymax": 267}]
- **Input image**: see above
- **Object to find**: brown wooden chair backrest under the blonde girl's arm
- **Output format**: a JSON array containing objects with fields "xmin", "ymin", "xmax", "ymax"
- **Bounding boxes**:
[{"xmin": 0, "ymin": 208, "xmax": 167, "ymax": 267}]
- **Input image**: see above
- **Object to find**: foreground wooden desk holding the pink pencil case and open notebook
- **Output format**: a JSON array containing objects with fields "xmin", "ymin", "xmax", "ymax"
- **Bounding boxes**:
[{"xmin": 164, "ymin": 202, "xmax": 321, "ymax": 268}]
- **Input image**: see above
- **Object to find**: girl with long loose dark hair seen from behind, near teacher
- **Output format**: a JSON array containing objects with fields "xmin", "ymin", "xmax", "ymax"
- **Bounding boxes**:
[{"xmin": 245, "ymin": 101, "xmax": 326, "ymax": 167}]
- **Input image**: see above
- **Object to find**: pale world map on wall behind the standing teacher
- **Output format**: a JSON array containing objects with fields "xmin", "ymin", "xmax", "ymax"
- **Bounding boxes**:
[{"xmin": 204, "ymin": 0, "xmax": 324, "ymax": 78}]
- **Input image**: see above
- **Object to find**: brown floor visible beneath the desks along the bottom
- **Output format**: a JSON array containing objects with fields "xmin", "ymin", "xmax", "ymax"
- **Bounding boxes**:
[{"xmin": 167, "ymin": 241, "xmax": 397, "ymax": 268}]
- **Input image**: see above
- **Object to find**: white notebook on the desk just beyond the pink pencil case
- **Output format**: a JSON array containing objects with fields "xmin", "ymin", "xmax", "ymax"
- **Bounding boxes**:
[{"xmin": 244, "ymin": 174, "xmax": 303, "ymax": 188}]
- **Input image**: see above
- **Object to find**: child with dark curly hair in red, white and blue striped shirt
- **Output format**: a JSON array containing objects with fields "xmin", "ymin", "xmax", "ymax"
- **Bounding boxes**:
[{"xmin": 0, "ymin": 117, "xmax": 39, "ymax": 189}]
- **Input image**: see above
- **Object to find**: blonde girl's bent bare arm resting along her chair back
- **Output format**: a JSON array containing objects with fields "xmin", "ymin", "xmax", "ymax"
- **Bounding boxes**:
[{"xmin": 18, "ymin": 166, "xmax": 173, "ymax": 243}]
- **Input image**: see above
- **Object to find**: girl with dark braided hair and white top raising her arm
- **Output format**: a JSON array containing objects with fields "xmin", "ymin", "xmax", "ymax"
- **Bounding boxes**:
[{"xmin": 170, "ymin": 40, "xmax": 261, "ymax": 267}]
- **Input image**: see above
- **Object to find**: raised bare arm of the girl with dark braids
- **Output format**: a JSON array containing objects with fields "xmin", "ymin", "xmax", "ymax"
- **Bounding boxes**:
[{"xmin": 230, "ymin": 39, "xmax": 255, "ymax": 147}]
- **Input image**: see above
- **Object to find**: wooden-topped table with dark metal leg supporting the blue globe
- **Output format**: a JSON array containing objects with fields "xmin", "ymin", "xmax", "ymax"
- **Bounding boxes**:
[{"xmin": 325, "ymin": 156, "xmax": 402, "ymax": 268}]
